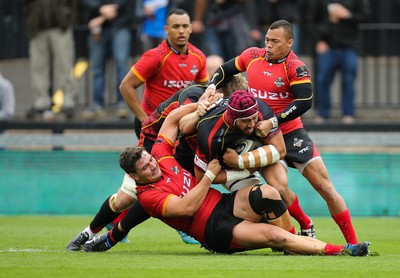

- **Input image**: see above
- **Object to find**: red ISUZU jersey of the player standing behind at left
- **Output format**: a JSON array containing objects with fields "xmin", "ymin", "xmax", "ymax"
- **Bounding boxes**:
[{"xmin": 131, "ymin": 41, "xmax": 208, "ymax": 115}]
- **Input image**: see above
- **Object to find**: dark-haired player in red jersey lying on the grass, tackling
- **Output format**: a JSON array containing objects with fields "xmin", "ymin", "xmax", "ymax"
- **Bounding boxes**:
[{"xmin": 82, "ymin": 101, "xmax": 369, "ymax": 256}]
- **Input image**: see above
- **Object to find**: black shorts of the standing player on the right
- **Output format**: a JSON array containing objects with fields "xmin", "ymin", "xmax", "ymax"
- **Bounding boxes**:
[{"xmin": 283, "ymin": 128, "xmax": 319, "ymax": 168}]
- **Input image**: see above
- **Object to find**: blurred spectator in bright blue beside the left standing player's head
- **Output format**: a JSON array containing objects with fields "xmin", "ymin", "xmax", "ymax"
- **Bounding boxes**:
[{"xmin": 137, "ymin": 0, "xmax": 168, "ymax": 51}]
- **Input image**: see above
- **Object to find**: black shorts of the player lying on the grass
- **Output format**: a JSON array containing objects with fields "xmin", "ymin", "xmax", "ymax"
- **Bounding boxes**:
[{"xmin": 203, "ymin": 192, "xmax": 243, "ymax": 253}]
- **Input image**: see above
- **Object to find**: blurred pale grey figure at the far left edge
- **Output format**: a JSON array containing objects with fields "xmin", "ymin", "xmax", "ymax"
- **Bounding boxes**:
[{"xmin": 0, "ymin": 72, "xmax": 15, "ymax": 122}]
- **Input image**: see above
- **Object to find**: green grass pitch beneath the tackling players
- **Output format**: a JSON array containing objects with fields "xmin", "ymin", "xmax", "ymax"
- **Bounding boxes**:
[{"xmin": 0, "ymin": 216, "xmax": 400, "ymax": 278}]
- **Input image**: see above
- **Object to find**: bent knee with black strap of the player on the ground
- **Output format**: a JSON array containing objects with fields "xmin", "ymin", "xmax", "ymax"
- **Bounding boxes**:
[{"xmin": 249, "ymin": 185, "xmax": 287, "ymax": 220}]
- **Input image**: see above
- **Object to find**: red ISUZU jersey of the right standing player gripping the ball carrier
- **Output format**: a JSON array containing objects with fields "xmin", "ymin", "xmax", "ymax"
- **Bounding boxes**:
[{"xmin": 235, "ymin": 47, "xmax": 311, "ymax": 134}]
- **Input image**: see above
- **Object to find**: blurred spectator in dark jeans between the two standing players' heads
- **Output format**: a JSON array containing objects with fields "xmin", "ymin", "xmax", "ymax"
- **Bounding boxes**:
[{"xmin": 192, "ymin": 0, "xmax": 252, "ymax": 61}]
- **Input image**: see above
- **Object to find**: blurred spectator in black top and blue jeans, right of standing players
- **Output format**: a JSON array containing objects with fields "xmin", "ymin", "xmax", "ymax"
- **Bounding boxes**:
[{"xmin": 310, "ymin": 0, "xmax": 370, "ymax": 124}]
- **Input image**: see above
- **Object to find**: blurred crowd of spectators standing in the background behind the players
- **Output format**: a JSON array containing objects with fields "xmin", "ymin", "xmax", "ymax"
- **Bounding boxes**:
[{"xmin": 0, "ymin": 0, "xmax": 399, "ymax": 123}]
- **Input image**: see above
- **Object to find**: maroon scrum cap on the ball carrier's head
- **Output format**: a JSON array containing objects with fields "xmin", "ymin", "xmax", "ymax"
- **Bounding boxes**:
[{"xmin": 226, "ymin": 90, "xmax": 258, "ymax": 125}]
